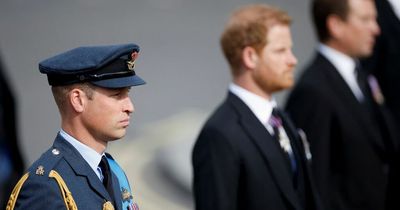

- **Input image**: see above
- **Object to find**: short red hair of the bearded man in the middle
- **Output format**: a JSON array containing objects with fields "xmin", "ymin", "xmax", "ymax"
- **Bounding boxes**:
[{"xmin": 220, "ymin": 4, "xmax": 291, "ymax": 75}]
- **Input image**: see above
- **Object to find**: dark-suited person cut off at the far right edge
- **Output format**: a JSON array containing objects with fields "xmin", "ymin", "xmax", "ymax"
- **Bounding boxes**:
[{"xmin": 363, "ymin": 0, "xmax": 400, "ymax": 129}]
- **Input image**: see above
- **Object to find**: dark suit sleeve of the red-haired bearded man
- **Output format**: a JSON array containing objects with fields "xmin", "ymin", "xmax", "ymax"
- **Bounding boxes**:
[{"xmin": 193, "ymin": 128, "xmax": 240, "ymax": 210}]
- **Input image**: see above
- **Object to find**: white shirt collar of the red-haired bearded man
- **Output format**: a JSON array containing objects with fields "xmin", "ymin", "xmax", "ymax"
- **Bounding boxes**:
[{"xmin": 229, "ymin": 83, "xmax": 277, "ymax": 130}]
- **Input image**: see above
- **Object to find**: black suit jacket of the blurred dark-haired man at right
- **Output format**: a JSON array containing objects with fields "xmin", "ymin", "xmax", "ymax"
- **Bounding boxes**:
[{"xmin": 286, "ymin": 53, "xmax": 396, "ymax": 210}]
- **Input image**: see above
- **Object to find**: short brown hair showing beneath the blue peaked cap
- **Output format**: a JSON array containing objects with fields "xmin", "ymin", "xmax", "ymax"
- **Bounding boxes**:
[{"xmin": 51, "ymin": 82, "xmax": 96, "ymax": 114}]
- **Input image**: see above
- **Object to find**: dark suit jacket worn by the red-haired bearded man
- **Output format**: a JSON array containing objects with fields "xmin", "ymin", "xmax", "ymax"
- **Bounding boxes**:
[{"xmin": 193, "ymin": 93, "xmax": 320, "ymax": 210}]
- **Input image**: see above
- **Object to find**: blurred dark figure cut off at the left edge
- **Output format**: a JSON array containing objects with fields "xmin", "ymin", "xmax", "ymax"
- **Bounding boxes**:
[{"xmin": 0, "ymin": 56, "xmax": 24, "ymax": 209}]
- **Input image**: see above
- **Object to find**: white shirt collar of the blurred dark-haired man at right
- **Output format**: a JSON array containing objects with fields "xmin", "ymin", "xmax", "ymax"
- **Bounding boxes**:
[{"xmin": 318, "ymin": 43, "xmax": 364, "ymax": 101}]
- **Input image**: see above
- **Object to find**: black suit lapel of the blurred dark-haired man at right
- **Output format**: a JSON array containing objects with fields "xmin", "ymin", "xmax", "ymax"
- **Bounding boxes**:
[{"xmin": 316, "ymin": 54, "xmax": 385, "ymax": 152}]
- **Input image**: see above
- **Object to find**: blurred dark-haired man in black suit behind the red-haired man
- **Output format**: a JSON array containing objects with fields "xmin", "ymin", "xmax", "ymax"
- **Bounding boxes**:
[{"xmin": 286, "ymin": 0, "xmax": 398, "ymax": 210}]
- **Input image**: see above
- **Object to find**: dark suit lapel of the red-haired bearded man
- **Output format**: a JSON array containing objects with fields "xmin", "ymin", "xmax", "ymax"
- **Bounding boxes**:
[{"xmin": 228, "ymin": 93, "xmax": 300, "ymax": 209}]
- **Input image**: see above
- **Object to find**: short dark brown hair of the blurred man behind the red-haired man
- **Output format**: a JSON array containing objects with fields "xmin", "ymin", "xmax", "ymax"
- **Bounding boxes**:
[{"xmin": 311, "ymin": 0, "xmax": 350, "ymax": 42}]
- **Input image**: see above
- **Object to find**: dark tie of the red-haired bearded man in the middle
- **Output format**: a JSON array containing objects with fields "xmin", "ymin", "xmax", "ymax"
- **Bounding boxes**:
[{"xmin": 269, "ymin": 108, "xmax": 297, "ymax": 173}]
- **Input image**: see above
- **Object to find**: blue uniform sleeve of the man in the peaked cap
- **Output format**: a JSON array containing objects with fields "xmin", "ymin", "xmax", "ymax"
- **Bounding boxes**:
[{"xmin": 14, "ymin": 174, "xmax": 66, "ymax": 210}]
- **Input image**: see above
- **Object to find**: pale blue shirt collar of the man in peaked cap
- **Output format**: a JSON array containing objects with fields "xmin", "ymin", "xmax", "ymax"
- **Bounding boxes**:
[{"xmin": 60, "ymin": 129, "xmax": 104, "ymax": 178}]
